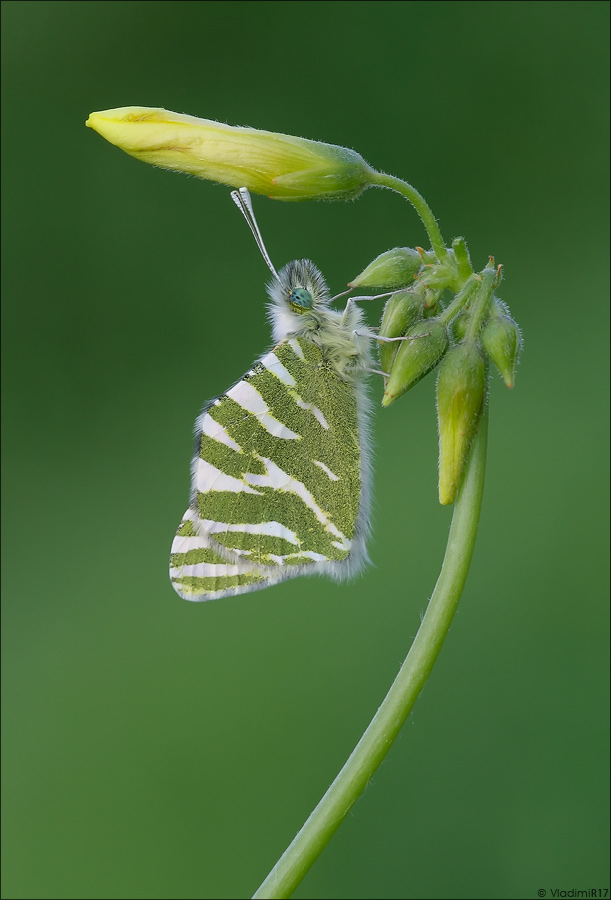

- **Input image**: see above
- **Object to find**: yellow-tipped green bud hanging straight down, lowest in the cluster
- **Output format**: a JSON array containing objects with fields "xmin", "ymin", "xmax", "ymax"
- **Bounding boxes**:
[{"xmin": 437, "ymin": 342, "xmax": 487, "ymax": 505}]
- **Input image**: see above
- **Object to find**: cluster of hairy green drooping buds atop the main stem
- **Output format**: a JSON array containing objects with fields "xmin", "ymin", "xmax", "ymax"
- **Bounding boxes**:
[{"xmin": 351, "ymin": 246, "xmax": 521, "ymax": 504}]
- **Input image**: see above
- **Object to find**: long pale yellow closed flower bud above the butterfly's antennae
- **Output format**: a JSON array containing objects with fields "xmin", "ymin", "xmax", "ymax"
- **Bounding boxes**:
[{"xmin": 86, "ymin": 106, "xmax": 373, "ymax": 200}]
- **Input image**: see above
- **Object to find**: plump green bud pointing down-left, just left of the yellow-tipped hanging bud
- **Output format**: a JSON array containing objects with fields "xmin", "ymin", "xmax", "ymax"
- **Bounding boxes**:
[{"xmin": 382, "ymin": 319, "xmax": 449, "ymax": 406}]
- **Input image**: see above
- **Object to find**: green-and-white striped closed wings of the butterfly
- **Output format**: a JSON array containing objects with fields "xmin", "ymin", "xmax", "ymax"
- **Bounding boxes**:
[{"xmin": 170, "ymin": 338, "xmax": 364, "ymax": 600}]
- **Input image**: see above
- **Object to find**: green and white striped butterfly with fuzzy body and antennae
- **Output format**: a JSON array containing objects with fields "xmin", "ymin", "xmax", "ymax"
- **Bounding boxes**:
[{"xmin": 170, "ymin": 188, "xmax": 371, "ymax": 600}]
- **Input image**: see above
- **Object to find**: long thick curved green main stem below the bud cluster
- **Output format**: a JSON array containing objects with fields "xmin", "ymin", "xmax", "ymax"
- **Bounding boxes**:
[{"xmin": 254, "ymin": 412, "xmax": 488, "ymax": 898}]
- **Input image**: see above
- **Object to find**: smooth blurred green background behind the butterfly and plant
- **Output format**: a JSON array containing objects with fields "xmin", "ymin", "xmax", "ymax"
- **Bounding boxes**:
[{"xmin": 2, "ymin": 0, "xmax": 609, "ymax": 898}]
